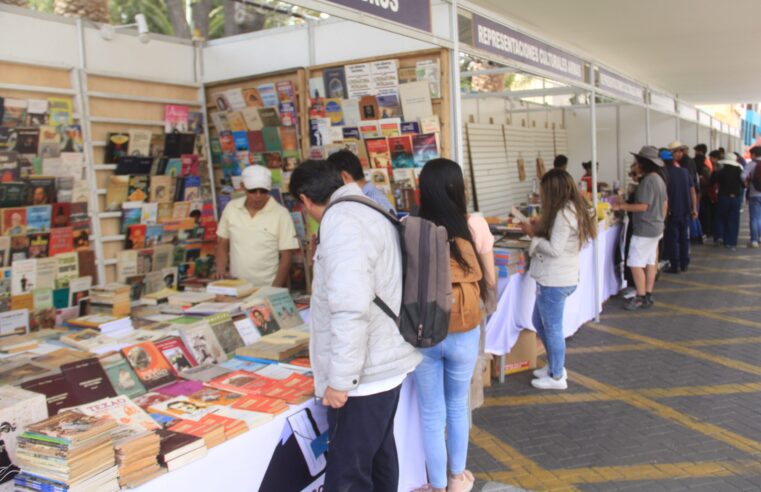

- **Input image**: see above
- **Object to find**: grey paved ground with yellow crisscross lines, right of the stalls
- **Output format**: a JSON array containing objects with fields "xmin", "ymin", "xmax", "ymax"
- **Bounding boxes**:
[{"xmin": 468, "ymin": 229, "xmax": 761, "ymax": 491}]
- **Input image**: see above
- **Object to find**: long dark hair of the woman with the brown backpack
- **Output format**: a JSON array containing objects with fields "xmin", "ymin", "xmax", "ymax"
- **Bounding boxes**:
[{"xmin": 416, "ymin": 158, "xmax": 487, "ymax": 299}]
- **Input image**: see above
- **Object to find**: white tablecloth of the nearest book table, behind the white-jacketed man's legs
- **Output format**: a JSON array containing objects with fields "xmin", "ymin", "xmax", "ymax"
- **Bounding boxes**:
[{"xmin": 137, "ymin": 377, "xmax": 426, "ymax": 492}]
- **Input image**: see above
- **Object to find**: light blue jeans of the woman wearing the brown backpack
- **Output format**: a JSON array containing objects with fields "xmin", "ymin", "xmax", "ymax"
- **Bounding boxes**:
[{"xmin": 413, "ymin": 328, "xmax": 481, "ymax": 488}]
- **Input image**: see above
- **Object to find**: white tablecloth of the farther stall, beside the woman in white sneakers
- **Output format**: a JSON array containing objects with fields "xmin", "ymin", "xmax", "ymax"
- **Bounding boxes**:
[{"xmin": 486, "ymin": 225, "xmax": 621, "ymax": 355}]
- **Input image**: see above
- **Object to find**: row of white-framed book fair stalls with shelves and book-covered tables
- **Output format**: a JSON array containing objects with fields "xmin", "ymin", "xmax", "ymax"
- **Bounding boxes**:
[{"xmin": 0, "ymin": 0, "xmax": 739, "ymax": 491}]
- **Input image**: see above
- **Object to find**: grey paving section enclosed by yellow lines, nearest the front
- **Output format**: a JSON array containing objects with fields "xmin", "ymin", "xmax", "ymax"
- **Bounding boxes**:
[{"xmin": 473, "ymin": 401, "xmax": 749, "ymax": 470}]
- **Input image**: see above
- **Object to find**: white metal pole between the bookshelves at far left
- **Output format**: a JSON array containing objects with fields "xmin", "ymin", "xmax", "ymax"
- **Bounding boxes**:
[{"xmin": 74, "ymin": 17, "xmax": 106, "ymax": 284}]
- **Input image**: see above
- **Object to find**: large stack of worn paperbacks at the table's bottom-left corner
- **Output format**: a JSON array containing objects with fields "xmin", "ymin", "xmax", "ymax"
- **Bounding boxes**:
[{"xmin": 15, "ymin": 410, "xmax": 119, "ymax": 492}]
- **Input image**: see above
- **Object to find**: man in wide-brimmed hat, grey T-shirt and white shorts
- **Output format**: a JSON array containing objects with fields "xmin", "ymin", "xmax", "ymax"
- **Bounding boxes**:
[{"xmin": 612, "ymin": 146, "xmax": 668, "ymax": 311}]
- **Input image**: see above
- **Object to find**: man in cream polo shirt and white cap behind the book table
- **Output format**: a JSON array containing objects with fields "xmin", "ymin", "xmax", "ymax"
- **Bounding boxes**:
[{"xmin": 216, "ymin": 165, "xmax": 299, "ymax": 287}]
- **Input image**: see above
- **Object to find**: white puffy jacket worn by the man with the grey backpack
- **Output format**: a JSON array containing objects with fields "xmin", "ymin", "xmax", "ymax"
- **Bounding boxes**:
[{"xmin": 310, "ymin": 183, "xmax": 422, "ymax": 396}]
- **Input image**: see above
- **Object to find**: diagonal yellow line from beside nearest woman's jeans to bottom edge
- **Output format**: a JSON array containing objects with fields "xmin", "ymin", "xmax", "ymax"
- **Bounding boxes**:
[{"xmin": 470, "ymin": 425, "xmax": 577, "ymax": 490}]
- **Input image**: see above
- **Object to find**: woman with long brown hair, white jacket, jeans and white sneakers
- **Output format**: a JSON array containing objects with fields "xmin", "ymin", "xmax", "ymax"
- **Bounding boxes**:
[{"xmin": 523, "ymin": 169, "xmax": 597, "ymax": 390}]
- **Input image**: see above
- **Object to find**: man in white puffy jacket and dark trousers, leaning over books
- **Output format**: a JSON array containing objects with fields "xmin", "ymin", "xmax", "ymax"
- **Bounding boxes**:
[{"xmin": 290, "ymin": 161, "xmax": 421, "ymax": 492}]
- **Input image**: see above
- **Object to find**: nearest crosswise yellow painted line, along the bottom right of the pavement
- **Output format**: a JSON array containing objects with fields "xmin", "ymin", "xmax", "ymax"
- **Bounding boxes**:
[{"xmin": 480, "ymin": 460, "xmax": 761, "ymax": 490}]
